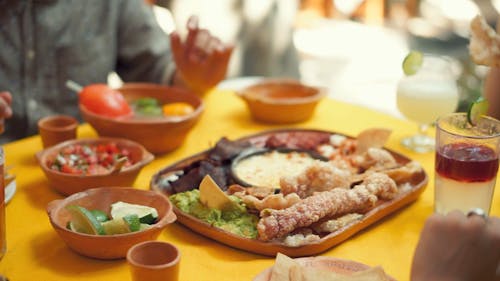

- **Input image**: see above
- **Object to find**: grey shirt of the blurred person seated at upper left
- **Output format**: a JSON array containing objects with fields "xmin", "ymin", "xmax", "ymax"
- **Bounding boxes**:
[{"xmin": 0, "ymin": 0, "xmax": 173, "ymax": 143}]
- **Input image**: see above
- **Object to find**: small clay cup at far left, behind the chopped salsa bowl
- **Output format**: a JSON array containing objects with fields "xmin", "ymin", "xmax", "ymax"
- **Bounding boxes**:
[{"xmin": 38, "ymin": 115, "xmax": 78, "ymax": 148}]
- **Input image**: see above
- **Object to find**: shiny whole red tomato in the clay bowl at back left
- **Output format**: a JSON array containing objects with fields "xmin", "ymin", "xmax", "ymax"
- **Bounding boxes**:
[{"xmin": 79, "ymin": 84, "xmax": 132, "ymax": 117}]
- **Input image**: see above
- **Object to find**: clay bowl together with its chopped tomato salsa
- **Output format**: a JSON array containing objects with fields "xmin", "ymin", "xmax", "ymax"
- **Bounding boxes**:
[{"xmin": 36, "ymin": 137, "xmax": 154, "ymax": 195}]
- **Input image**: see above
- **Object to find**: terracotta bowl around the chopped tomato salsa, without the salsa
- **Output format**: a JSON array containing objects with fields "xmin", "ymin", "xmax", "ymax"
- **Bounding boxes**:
[{"xmin": 36, "ymin": 137, "xmax": 154, "ymax": 195}]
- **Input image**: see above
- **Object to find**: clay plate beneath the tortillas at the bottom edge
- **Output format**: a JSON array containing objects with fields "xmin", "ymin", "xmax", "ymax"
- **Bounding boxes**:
[{"xmin": 253, "ymin": 256, "xmax": 395, "ymax": 281}]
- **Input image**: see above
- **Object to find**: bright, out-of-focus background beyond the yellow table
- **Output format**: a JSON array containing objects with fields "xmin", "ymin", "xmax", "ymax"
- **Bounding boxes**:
[{"xmin": 145, "ymin": 0, "xmax": 500, "ymax": 117}]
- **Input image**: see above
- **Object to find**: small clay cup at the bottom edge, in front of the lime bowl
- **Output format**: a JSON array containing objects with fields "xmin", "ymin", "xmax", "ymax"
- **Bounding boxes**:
[{"xmin": 127, "ymin": 241, "xmax": 181, "ymax": 281}]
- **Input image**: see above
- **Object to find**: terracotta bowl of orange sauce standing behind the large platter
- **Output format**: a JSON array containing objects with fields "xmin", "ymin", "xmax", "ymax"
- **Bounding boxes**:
[{"xmin": 237, "ymin": 79, "xmax": 326, "ymax": 124}]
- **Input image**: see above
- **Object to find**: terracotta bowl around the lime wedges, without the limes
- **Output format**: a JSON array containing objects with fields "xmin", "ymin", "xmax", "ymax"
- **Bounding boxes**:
[{"xmin": 47, "ymin": 187, "xmax": 176, "ymax": 259}]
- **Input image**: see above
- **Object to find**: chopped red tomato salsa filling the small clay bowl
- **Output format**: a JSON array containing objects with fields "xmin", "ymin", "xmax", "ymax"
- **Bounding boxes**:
[{"xmin": 47, "ymin": 143, "xmax": 133, "ymax": 175}]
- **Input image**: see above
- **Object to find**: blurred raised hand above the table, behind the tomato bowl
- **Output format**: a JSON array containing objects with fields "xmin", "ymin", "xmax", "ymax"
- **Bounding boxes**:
[{"xmin": 170, "ymin": 16, "xmax": 233, "ymax": 94}]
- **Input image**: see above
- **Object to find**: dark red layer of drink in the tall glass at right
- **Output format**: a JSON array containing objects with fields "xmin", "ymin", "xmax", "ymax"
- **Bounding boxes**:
[{"xmin": 435, "ymin": 143, "xmax": 498, "ymax": 182}]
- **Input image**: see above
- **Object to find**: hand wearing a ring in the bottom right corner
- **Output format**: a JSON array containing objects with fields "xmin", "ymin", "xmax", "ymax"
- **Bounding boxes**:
[{"xmin": 411, "ymin": 211, "xmax": 500, "ymax": 281}]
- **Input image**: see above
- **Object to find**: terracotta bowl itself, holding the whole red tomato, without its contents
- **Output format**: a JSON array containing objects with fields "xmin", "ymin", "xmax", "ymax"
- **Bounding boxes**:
[{"xmin": 80, "ymin": 83, "xmax": 204, "ymax": 154}]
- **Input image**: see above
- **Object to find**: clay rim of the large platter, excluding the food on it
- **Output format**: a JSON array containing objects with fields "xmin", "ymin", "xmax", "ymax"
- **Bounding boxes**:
[{"xmin": 150, "ymin": 129, "xmax": 428, "ymax": 257}]
